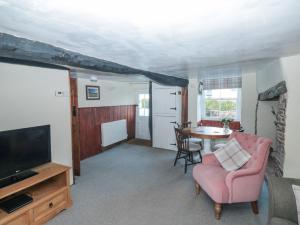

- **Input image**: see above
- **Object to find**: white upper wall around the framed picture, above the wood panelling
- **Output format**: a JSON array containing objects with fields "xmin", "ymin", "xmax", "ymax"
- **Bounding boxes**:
[{"xmin": 77, "ymin": 78, "xmax": 136, "ymax": 108}]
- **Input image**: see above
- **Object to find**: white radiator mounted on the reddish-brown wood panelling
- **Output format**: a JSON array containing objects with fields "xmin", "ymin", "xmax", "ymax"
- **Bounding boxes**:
[{"xmin": 101, "ymin": 120, "xmax": 128, "ymax": 147}]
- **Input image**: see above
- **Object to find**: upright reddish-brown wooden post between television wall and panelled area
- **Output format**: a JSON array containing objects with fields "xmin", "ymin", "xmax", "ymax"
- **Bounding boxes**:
[{"xmin": 70, "ymin": 77, "xmax": 80, "ymax": 176}]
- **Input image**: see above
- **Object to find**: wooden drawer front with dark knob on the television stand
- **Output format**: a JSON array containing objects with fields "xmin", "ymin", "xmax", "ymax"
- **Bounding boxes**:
[{"xmin": 33, "ymin": 191, "xmax": 67, "ymax": 223}]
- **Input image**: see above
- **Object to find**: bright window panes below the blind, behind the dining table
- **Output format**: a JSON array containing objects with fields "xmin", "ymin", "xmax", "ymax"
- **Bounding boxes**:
[{"xmin": 201, "ymin": 88, "xmax": 241, "ymax": 121}]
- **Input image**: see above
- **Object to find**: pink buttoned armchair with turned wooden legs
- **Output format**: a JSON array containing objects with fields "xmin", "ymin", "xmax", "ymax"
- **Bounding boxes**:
[{"xmin": 193, "ymin": 132, "xmax": 272, "ymax": 219}]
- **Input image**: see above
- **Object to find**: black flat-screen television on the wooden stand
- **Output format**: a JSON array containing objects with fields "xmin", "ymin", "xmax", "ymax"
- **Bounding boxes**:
[{"xmin": 0, "ymin": 125, "xmax": 51, "ymax": 179}]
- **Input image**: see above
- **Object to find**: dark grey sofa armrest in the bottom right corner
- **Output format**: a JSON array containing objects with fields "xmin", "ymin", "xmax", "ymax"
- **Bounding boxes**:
[{"xmin": 267, "ymin": 176, "xmax": 300, "ymax": 224}]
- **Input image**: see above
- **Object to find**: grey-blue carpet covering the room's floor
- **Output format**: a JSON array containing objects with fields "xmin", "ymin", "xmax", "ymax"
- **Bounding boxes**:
[{"xmin": 48, "ymin": 143, "xmax": 268, "ymax": 225}]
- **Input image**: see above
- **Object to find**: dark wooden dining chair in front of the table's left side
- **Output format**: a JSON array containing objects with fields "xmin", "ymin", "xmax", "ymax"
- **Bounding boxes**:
[{"xmin": 174, "ymin": 128, "xmax": 202, "ymax": 173}]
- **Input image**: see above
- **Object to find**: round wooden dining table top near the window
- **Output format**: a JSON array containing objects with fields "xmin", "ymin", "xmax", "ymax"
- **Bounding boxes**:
[{"xmin": 183, "ymin": 126, "xmax": 232, "ymax": 139}]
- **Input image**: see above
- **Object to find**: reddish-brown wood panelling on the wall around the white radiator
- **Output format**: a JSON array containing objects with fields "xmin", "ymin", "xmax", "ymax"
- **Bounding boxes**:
[{"xmin": 78, "ymin": 105, "xmax": 136, "ymax": 160}]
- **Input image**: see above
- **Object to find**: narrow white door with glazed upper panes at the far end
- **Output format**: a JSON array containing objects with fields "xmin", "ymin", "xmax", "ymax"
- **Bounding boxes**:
[{"xmin": 135, "ymin": 90, "xmax": 150, "ymax": 140}]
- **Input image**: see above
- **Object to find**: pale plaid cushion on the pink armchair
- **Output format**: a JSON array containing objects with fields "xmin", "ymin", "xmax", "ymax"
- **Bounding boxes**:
[{"xmin": 214, "ymin": 138, "xmax": 251, "ymax": 171}]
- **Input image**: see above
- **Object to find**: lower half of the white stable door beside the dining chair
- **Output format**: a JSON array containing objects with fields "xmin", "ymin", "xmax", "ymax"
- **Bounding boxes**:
[{"xmin": 153, "ymin": 116, "xmax": 177, "ymax": 150}]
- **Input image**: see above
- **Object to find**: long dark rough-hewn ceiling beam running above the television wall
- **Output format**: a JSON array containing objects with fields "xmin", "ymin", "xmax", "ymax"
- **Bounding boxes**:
[{"xmin": 0, "ymin": 33, "xmax": 188, "ymax": 87}]
